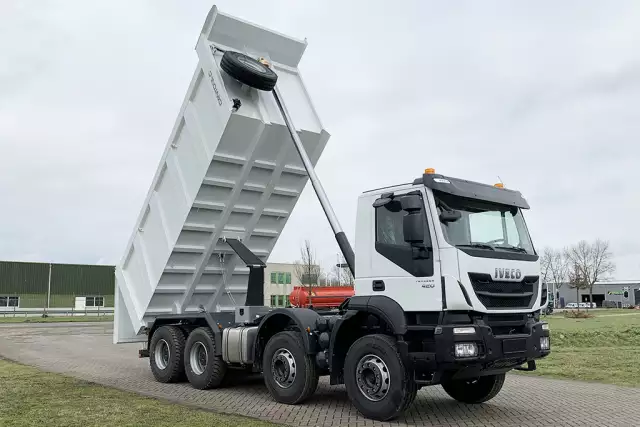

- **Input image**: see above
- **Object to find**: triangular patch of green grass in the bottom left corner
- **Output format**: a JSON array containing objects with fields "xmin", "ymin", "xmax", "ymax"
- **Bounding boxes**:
[{"xmin": 0, "ymin": 360, "xmax": 274, "ymax": 427}]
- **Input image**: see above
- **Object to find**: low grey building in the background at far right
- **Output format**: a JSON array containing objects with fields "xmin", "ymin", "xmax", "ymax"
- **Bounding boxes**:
[{"xmin": 556, "ymin": 280, "xmax": 640, "ymax": 307}]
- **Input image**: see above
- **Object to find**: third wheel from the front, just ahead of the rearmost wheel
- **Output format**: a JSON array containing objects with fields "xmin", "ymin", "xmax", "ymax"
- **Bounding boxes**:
[{"xmin": 184, "ymin": 327, "xmax": 227, "ymax": 390}]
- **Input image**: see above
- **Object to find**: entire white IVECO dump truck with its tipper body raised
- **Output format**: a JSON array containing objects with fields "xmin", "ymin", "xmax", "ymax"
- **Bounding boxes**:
[{"xmin": 114, "ymin": 6, "xmax": 550, "ymax": 420}]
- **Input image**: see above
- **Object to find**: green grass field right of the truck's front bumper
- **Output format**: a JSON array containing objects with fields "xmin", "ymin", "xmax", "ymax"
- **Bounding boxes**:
[{"xmin": 514, "ymin": 310, "xmax": 640, "ymax": 387}]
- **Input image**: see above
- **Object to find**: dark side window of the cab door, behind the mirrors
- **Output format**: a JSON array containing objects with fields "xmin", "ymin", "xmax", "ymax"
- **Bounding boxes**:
[{"xmin": 374, "ymin": 194, "xmax": 433, "ymax": 277}]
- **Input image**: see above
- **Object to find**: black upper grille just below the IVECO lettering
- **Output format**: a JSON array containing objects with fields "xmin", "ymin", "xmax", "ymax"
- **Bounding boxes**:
[{"xmin": 469, "ymin": 273, "xmax": 538, "ymax": 309}]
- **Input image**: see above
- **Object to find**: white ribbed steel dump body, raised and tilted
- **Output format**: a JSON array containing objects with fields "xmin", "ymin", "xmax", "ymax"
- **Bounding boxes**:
[{"xmin": 114, "ymin": 6, "xmax": 329, "ymax": 343}]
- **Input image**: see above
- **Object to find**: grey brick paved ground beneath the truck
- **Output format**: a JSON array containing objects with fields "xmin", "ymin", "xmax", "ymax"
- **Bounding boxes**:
[{"xmin": 0, "ymin": 323, "xmax": 640, "ymax": 427}]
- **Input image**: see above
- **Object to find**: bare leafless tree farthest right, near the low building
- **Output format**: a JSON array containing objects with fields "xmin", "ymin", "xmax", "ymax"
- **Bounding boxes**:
[{"xmin": 565, "ymin": 239, "xmax": 616, "ymax": 308}]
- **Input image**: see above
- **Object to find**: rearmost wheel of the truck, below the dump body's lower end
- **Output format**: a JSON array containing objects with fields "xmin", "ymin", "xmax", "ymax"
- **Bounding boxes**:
[{"xmin": 149, "ymin": 325, "xmax": 185, "ymax": 383}]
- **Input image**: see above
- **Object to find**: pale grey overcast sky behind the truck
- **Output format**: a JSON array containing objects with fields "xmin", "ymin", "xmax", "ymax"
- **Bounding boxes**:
[{"xmin": 0, "ymin": 0, "xmax": 640, "ymax": 279}]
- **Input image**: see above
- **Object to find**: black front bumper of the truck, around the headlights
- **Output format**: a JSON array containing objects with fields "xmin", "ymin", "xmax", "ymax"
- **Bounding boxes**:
[{"xmin": 412, "ymin": 319, "xmax": 551, "ymax": 377}]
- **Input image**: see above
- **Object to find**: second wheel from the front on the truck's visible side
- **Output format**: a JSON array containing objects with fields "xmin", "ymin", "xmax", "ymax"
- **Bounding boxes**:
[{"xmin": 262, "ymin": 331, "xmax": 319, "ymax": 405}]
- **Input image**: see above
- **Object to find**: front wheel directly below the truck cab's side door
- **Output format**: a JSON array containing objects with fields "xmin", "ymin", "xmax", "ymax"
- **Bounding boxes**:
[{"xmin": 344, "ymin": 335, "xmax": 418, "ymax": 421}]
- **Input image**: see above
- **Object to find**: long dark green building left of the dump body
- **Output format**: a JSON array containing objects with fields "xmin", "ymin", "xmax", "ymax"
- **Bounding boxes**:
[{"xmin": 0, "ymin": 261, "xmax": 115, "ymax": 315}]
